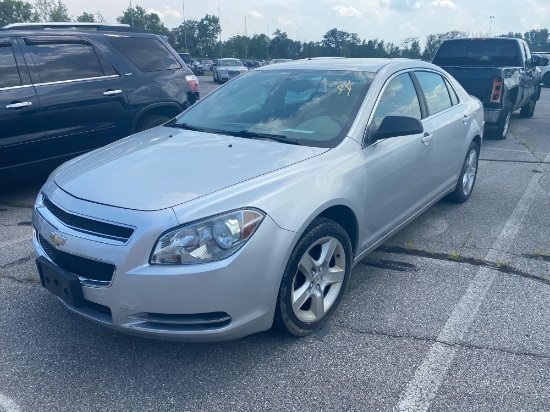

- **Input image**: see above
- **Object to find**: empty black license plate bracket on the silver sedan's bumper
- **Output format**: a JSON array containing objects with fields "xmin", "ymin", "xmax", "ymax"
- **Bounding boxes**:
[{"xmin": 36, "ymin": 256, "xmax": 84, "ymax": 307}]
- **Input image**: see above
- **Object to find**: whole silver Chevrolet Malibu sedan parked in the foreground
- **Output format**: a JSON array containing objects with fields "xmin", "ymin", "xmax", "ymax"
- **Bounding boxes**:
[{"xmin": 33, "ymin": 59, "xmax": 483, "ymax": 341}]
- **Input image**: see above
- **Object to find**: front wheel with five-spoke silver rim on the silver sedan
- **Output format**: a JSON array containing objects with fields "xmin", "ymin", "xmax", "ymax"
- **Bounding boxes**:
[{"xmin": 274, "ymin": 218, "xmax": 352, "ymax": 336}]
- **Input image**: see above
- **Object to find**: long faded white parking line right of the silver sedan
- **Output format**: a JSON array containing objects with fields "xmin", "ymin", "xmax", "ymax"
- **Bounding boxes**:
[{"xmin": 394, "ymin": 155, "xmax": 550, "ymax": 412}]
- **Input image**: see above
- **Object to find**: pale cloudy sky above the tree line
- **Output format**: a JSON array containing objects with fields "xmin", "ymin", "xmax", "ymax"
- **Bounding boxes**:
[{"xmin": 64, "ymin": 0, "xmax": 550, "ymax": 45}]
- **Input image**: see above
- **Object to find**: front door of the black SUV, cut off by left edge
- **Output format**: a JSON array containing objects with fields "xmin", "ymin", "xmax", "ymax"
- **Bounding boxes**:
[{"xmin": 0, "ymin": 37, "xmax": 46, "ymax": 184}]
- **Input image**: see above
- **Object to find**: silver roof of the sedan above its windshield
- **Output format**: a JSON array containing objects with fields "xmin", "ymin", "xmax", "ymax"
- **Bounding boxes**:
[{"xmin": 256, "ymin": 58, "xmax": 439, "ymax": 72}]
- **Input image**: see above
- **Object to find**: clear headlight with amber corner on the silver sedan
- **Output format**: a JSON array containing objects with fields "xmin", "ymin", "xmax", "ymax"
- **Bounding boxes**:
[{"xmin": 149, "ymin": 209, "xmax": 265, "ymax": 265}]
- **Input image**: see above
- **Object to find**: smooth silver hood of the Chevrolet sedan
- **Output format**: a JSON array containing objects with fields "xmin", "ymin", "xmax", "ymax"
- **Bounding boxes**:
[{"xmin": 54, "ymin": 126, "xmax": 328, "ymax": 210}]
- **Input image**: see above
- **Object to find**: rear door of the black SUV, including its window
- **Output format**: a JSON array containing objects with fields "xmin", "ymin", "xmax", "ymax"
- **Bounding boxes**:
[{"xmin": 22, "ymin": 36, "xmax": 129, "ymax": 163}]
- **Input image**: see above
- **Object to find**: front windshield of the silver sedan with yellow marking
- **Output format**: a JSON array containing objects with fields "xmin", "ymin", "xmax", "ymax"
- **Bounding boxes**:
[{"xmin": 175, "ymin": 69, "xmax": 375, "ymax": 147}]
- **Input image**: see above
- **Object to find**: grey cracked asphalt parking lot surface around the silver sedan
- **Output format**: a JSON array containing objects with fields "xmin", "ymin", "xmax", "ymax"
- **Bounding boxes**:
[{"xmin": 0, "ymin": 85, "xmax": 550, "ymax": 412}]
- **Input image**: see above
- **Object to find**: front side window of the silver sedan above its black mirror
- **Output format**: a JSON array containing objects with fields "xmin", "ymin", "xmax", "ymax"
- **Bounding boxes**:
[{"xmin": 373, "ymin": 74, "xmax": 422, "ymax": 129}]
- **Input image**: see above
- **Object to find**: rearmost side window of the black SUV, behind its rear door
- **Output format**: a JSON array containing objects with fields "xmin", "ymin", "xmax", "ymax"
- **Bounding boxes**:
[{"xmin": 107, "ymin": 36, "xmax": 181, "ymax": 72}]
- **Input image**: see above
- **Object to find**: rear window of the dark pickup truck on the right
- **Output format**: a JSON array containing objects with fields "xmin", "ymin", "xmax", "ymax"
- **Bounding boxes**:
[{"xmin": 432, "ymin": 39, "xmax": 521, "ymax": 67}]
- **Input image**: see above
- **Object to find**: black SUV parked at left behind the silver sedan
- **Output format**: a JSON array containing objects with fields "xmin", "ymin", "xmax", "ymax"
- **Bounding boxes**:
[{"xmin": 0, "ymin": 23, "xmax": 199, "ymax": 186}]
